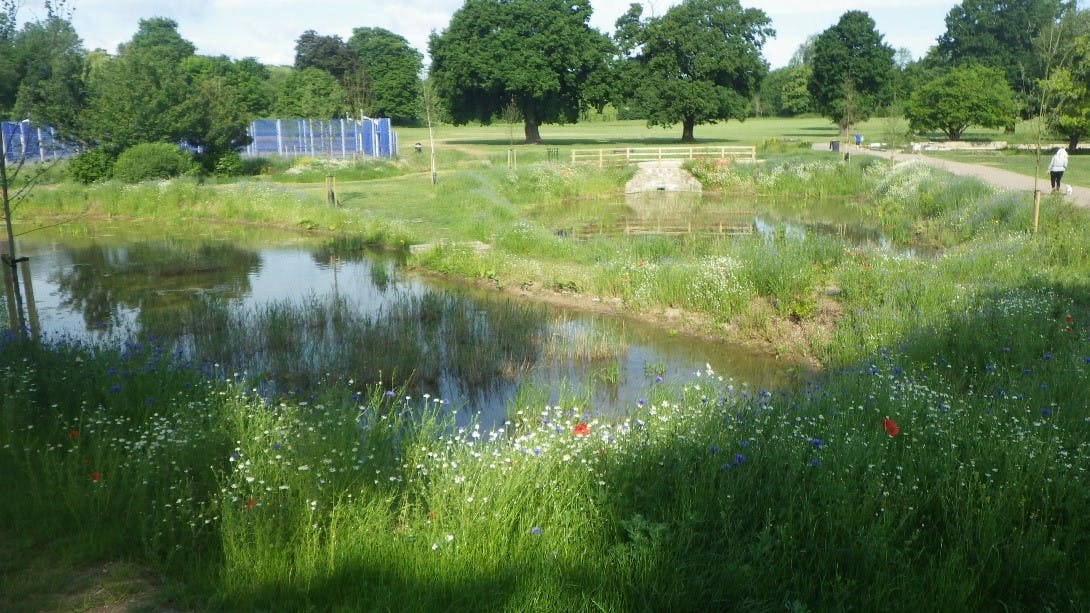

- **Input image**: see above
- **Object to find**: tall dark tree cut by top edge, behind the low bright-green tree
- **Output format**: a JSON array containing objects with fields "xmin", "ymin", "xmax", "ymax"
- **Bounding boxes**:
[{"xmin": 931, "ymin": 0, "xmax": 1074, "ymax": 97}]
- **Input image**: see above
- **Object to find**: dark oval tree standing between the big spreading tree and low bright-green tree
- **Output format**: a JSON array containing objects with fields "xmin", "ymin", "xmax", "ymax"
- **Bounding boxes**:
[{"xmin": 808, "ymin": 11, "xmax": 894, "ymax": 133}]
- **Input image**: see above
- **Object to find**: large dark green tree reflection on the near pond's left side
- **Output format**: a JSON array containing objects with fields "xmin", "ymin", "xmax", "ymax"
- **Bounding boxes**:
[{"xmin": 51, "ymin": 242, "xmax": 261, "ymax": 337}]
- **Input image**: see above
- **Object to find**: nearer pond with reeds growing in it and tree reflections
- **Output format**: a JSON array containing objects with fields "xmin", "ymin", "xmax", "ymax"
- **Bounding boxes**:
[{"xmin": 6, "ymin": 221, "xmax": 795, "ymax": 423}]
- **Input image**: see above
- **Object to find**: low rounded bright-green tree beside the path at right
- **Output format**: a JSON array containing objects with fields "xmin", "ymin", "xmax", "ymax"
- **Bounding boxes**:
[{"xmin": 905, "ymin": 64, "xmax": 1017, "ymax": 141}]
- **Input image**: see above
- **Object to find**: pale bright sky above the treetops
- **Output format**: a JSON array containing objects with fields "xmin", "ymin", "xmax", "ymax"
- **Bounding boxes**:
[{"xmin": 12, "ymin": 0, "xmax": 960, "ymax": 69}]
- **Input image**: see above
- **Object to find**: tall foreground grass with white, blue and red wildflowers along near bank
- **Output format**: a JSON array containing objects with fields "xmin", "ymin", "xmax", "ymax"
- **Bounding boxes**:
[{"xmin": 0, "ymin": 286, "xmax": 1090, "ymax": 611}]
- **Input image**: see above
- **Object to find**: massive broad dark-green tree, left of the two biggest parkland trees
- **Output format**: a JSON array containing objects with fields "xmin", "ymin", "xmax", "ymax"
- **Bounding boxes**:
[{"xmin": 428, "ymin": 0, "xmax": 613, "ymax": 143}]
